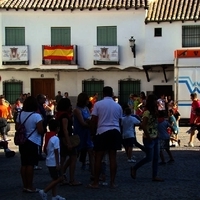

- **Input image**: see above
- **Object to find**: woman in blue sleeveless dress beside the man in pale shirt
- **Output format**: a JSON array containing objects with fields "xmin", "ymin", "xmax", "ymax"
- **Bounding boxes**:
[{"xmin": 73, "ymin": 92, "xmax": 94, "ymax": 178}]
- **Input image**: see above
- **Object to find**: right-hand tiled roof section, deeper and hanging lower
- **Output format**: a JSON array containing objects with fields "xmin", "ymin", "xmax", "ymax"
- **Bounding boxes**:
[{"xmin": 145, "ymin": 0, "xmax": 200, "ymax": 23}]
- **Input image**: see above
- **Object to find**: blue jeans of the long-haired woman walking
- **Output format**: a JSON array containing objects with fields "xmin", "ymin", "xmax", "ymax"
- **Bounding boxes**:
[{"xmin": 134, "ymin": 138, "xmax": 160, "ymax": 178}]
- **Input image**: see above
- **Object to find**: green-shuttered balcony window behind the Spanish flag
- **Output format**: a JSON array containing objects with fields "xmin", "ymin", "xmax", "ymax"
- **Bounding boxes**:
[{"xmin": 51, "ymin": 27, "xmax": 71, "ymax": 64}]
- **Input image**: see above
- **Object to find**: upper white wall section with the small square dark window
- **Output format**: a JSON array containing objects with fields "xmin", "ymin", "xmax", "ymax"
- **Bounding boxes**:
[{"xmin": 144, "ymin": 21, "xmax": 200, "ymax": 65}]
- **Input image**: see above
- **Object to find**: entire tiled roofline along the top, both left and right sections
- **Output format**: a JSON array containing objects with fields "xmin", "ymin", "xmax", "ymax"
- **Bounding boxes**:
[{"xmin": 0, "ymin": 0, "xmax": 200, "ymax": 23}]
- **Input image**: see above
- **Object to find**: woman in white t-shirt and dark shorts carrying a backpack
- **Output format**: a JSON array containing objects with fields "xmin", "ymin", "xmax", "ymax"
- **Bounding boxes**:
[{"xmin": 16, "ymin": 96, "xmax": 43, "ymax": 193}]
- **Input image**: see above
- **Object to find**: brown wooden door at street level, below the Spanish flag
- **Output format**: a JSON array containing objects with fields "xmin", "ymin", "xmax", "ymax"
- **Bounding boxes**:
[{"xmin": 31, "ymin": 78, "xmax": 55, "ymax": 99}]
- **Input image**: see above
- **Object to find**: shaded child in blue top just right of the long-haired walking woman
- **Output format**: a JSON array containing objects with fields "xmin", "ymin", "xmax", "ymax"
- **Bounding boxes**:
[{"xmin": 158, "ymin": 111, "xmax": 174, "ymax": 165}]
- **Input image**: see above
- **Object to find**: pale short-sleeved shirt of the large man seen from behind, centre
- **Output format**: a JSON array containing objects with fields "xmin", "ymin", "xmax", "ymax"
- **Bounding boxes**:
[{"xmin": 92, "ymin": 97, "xmax": 122, "ymax": 135}]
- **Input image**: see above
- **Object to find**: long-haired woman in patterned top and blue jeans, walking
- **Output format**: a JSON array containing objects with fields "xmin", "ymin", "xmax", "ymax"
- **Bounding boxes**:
[{"xmin": 131, "ymin": 95, "xmax": 163, "ymax": 181}]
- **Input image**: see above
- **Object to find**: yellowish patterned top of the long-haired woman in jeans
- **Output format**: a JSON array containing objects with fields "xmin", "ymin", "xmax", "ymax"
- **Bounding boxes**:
[{"xmin": 143, "ymin": 110, "xmax": 158, "ymax": 138}]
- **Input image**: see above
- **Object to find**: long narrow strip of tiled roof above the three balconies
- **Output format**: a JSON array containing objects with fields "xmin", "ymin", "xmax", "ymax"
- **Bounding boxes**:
[{"xmin": 0, "ymin": 0, "xmax": 148, "ymax": 10}]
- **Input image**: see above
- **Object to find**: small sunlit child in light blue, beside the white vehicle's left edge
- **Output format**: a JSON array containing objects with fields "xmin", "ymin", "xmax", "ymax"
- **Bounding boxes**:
[{"xmin": 168, "ymin": 109, "xmax": 180, "ymax": 146}]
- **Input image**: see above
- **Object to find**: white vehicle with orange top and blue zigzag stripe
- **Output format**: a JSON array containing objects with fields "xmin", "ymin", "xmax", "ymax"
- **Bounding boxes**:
[{"xmin": 174, "ymin": 48, "xmax": 200, "ymax": 125}]
